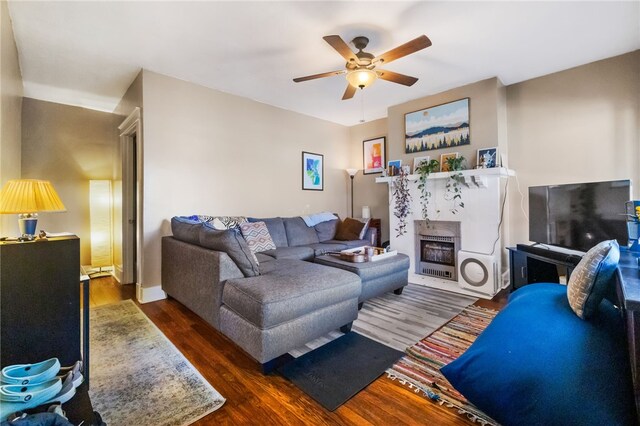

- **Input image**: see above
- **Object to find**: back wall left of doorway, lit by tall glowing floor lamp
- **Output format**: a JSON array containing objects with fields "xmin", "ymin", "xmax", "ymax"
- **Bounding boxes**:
[{"xmin": 22, "ymin": 98, "xmax": 121, "ymax": 265}]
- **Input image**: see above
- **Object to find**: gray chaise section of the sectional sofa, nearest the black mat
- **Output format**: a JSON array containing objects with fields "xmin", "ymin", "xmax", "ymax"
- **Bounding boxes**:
[{"xmin": 220, "ymin": 259, "xmax": 361, "ymax": 371}]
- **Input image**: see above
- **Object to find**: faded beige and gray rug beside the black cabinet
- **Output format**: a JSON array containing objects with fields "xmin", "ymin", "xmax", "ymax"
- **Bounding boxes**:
[{"xmin": 89, "ymin": 300, "xmax": 225, "ymax": 426}]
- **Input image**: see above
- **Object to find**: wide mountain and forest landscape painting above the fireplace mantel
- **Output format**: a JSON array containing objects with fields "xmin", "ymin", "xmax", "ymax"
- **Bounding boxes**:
[{"xmin": 404, "ymin": 98, "xmax": 471, "ymax": 154}]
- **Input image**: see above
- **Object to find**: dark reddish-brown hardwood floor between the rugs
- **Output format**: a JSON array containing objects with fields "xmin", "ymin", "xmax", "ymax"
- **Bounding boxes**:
[{"xmin": 90, "ymin": 278, "xmax": 506, "ymax": 426}]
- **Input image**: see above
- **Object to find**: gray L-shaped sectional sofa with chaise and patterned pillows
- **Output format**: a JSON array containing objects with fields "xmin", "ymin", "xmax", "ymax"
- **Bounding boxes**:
[{"xmin": 162, "ymin": 217, "xmax": 408, "ymax": 371}]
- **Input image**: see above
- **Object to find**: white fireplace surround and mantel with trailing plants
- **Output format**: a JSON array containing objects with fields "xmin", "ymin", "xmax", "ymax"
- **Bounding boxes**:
[{"xmin": 376, "ymin": 168, "xmax": 515, "ymax": 298}]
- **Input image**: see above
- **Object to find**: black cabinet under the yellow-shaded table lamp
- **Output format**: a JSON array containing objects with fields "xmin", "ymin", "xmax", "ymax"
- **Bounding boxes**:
[{"xmin": 0, "ymin": 236, "xmax": 93, "ymax": 425}]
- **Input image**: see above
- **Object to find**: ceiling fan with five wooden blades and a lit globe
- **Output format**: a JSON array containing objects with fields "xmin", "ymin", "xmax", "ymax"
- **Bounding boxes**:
[{"xmin": 293, "ymin": 35, "xmax": 431, "ymax": 100}]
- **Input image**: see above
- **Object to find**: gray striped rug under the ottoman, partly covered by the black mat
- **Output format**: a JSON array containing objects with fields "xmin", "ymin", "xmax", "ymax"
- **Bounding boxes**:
[{"xmin": 289, "ymin": 284, "xmax": 477, "ymax": 357}]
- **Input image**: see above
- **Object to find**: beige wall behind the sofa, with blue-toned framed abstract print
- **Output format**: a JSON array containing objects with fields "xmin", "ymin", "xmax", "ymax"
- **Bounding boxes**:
[{"xmin": 141, "ymin": 70, "xmax": 350, "ymax": 287}]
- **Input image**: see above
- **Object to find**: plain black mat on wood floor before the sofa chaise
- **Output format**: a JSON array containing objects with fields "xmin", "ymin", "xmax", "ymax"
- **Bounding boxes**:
[{"xmin": 277, "ymin": 332, "xmax": 404, "ymax": 411}]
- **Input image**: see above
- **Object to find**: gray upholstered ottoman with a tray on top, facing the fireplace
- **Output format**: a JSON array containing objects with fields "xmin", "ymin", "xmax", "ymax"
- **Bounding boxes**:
[{"xmin": 314, "ymin": 253, "xmax": 409, "ymax": 309}]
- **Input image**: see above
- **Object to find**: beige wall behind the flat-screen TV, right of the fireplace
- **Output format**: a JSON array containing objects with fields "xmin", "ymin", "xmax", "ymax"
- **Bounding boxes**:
[{"xmin": 507, "ymin": 51, "xmax": 640, "ymax": 243}]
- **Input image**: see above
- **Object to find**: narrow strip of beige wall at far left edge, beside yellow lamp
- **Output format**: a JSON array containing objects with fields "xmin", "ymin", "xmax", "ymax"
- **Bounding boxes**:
[{"xmin": 0, "ymin": 0, "xmax": 22, "ymax": 236}]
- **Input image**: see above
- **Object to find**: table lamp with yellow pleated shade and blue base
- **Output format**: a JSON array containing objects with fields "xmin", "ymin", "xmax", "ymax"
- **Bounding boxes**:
[{"xmin": 0, "ymin": 179, "xmax": 66, "ymax": 241}]
